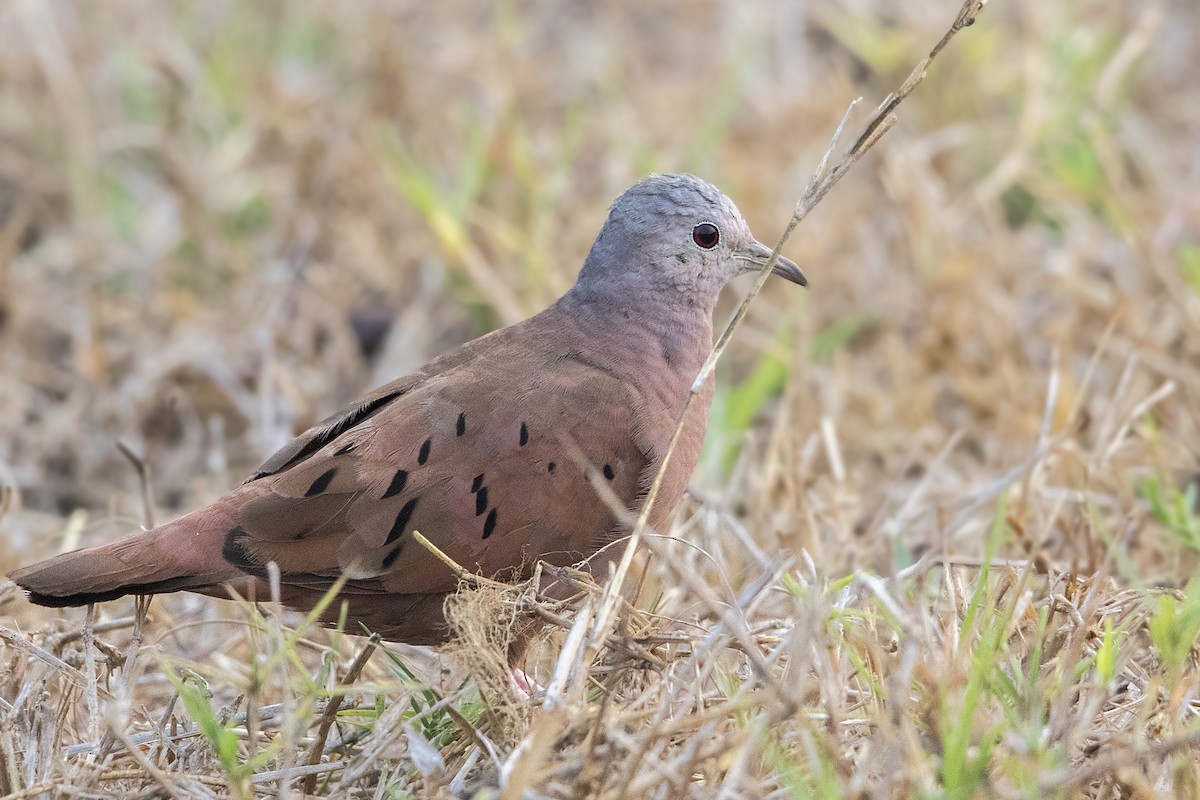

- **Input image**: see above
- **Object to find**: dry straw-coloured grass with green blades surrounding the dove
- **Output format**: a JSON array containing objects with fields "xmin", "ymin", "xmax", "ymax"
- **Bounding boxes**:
[{"xmin": 0, "ymin": 0, "xmax": 1200, "ymax": 799}]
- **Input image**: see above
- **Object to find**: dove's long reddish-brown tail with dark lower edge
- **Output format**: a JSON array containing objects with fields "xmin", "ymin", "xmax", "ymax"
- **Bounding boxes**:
[{"xmin": 8, "ymin": 505, "xmax": 238, "ymax": 607}]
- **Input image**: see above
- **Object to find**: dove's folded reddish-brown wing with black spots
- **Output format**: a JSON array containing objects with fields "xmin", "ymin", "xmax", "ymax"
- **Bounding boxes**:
[{"xmin": 224, "ymin": 342, "xmax": 648, "ymax": 594}]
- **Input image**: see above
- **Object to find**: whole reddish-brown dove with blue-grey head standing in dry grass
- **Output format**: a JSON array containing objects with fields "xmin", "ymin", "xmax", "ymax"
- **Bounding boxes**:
[{"xmin": 10, "ymin": 174, "xmax": 808, "ymax": 645}]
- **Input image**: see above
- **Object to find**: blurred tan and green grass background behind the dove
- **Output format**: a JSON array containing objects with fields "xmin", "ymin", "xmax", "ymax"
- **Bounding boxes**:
[{"xmin": 0, "ymin": 0, "xmax": 1200, "ymax": 594}]
